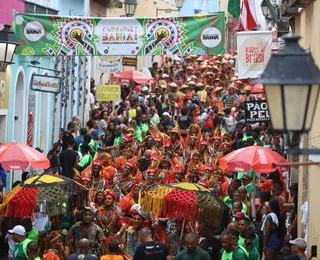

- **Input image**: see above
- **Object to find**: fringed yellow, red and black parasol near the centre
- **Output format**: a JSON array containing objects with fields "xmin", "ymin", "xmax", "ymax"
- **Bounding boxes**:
[{"xmin": 142, "ymin": 182, "xmax": 224, "ymax": 226}]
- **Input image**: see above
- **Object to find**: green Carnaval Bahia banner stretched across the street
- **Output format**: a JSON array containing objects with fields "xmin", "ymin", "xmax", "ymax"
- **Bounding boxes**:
[{"xmin": 14, "ymin": 12, "xmax": 225, "ymax": 56}]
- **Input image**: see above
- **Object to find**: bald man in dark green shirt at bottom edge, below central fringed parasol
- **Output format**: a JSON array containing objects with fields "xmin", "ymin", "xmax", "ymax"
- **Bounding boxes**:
[{"xmin": 174, "ymin": 233, "xmax": 211, "ymax": 260}]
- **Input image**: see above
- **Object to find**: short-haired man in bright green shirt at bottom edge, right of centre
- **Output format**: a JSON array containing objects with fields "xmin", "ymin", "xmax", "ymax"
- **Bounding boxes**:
[{"xmin": 220, "ymin": 231, "xmax": 247, "ymax": 260}]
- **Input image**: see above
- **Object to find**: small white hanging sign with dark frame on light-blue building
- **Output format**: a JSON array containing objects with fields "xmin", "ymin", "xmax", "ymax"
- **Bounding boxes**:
[{"xmin": 31, "ymin": 74, "xmax": 61, "ymax": 93}]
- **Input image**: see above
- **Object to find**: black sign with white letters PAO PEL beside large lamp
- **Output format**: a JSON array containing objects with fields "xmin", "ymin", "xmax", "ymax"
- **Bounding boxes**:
[{"xmin": 245, "ymin": 101, "xmax": 270, "ymax": 124}]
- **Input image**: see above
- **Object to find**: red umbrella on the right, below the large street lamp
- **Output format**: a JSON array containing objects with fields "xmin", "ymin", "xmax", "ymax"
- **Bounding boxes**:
[{"xmin": 219, "ymin": 146, "xmax": 288, "ymax": 172}]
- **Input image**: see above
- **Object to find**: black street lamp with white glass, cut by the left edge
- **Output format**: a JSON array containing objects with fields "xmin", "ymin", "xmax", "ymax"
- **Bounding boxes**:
[{"xmin": 0, "ymin": 24, "xmax": 19, "ymax": 72}]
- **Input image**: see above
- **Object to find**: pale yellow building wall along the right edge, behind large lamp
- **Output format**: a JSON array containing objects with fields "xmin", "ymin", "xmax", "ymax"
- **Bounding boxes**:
[{"xmin": 295, "ymin": 0, "xmax": 320, "ymax": 259}]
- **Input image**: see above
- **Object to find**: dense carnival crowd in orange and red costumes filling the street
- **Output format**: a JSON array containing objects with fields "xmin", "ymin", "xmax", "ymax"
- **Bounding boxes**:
[{"xmin": 0, "ymin": 55, "xmax": 307, "ymax": 260}]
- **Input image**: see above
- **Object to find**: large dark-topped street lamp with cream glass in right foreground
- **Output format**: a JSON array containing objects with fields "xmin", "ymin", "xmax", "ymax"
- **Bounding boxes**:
[{"xmin": 258, "ymin": 35, "xmax": 320, "ymax": 136}]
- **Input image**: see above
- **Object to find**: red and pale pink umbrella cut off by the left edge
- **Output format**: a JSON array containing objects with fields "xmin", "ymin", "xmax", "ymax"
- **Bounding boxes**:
[{"xmin": 0, "ymin": 142, "xmax": 50, "ymax": 170}]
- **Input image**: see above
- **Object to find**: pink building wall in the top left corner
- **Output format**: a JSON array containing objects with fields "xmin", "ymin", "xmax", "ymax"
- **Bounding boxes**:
[{"xmin": 0, "ymin": 0, "xmax": 24, "ymax": 24}]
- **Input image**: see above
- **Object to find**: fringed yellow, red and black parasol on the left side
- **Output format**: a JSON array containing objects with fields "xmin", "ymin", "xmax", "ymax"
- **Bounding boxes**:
[{"xmin": 0, "ymin": 174, "xmax": 88, "ymax": 218}]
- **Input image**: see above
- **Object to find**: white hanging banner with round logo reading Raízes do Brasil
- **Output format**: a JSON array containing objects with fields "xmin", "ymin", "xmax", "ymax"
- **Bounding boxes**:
[{"xmin": 237, "ymin": 31, "xmax": 272, "ymax": 79}]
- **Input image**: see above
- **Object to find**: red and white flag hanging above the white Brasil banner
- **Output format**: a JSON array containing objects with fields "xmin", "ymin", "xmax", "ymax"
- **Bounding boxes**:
[{"xmin": 241, "ymin": 0, "xmax": 257, "ymax": 31}]
